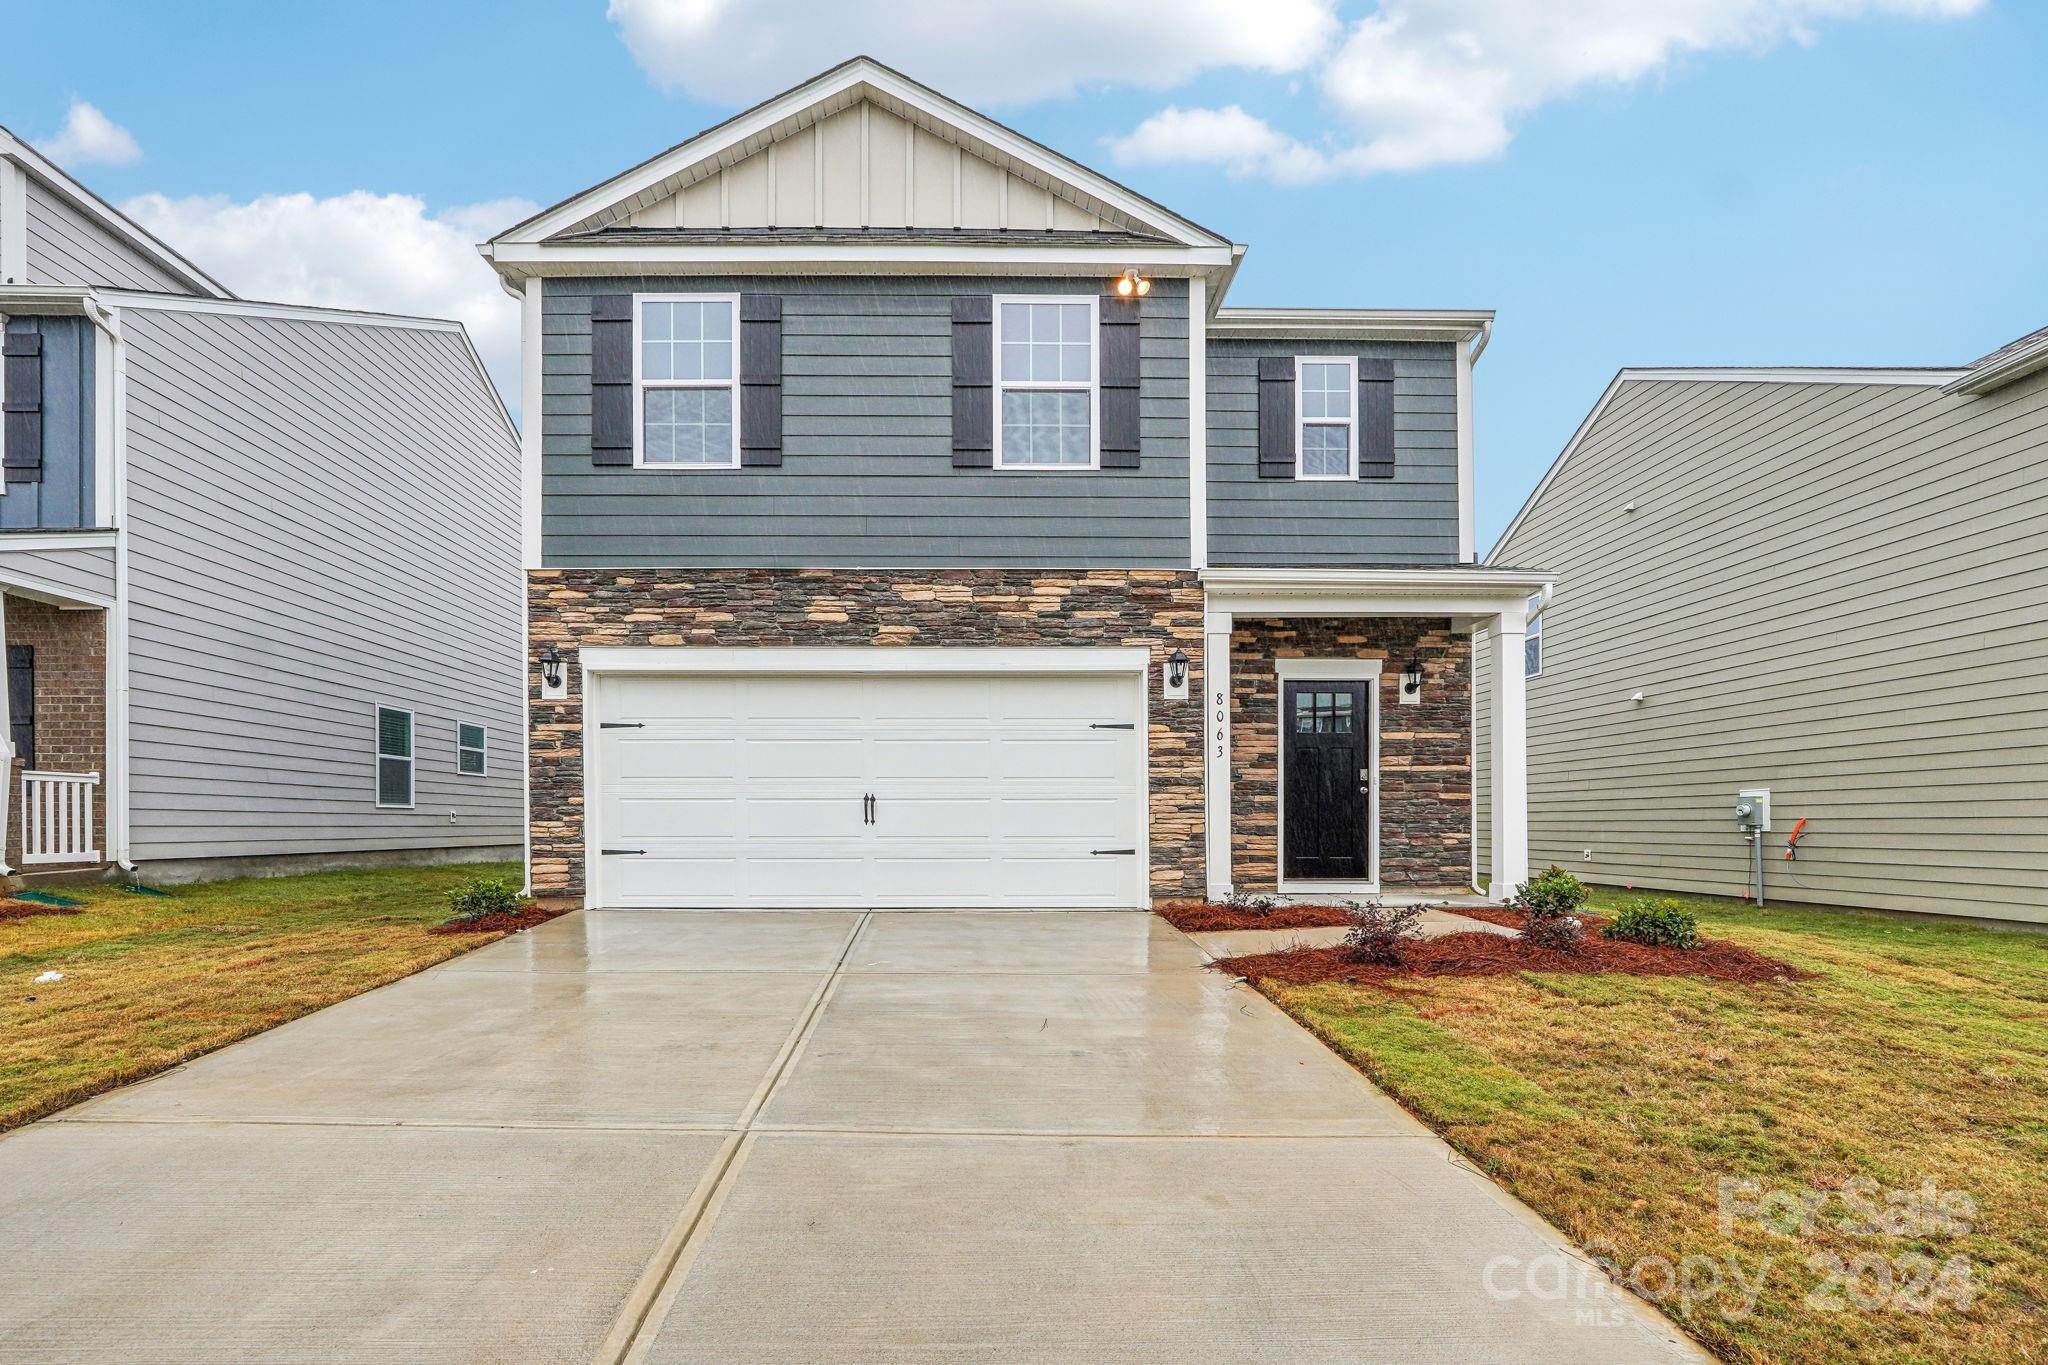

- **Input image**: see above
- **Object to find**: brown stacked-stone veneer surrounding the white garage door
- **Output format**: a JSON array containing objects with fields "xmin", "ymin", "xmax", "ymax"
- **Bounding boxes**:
[{"xmin": 526, "ymin": 569, "xmax": 1202, "ymax": 898}]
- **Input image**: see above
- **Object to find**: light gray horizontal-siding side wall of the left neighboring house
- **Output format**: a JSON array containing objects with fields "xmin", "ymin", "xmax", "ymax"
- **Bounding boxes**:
[{"xmin": 123, "ymin": 307, "xmax": 524, "ymax": 864}]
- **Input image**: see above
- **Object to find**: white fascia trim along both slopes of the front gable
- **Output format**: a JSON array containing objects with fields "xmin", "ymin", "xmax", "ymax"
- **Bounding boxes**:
[{"xmin": 492, "ymin": 57, "xmax": 1229, "ymax": 246}]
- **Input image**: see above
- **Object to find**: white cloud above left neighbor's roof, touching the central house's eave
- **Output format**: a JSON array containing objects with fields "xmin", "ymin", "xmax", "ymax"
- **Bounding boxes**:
[{"xmin": 121, "ymin": 190, "xmax": 535, "ymax": 411}]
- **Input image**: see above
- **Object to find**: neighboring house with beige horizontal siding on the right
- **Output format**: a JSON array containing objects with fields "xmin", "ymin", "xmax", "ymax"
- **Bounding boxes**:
[{"xmin": 1493, "ymin": 329, "xmax": 2048, "ymax": 921}]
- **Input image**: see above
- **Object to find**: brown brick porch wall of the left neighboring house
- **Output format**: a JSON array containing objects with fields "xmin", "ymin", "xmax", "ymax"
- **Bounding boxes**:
[{"xmin": 6, "ymin": 598, "xmax": 106, "ymax": 868}]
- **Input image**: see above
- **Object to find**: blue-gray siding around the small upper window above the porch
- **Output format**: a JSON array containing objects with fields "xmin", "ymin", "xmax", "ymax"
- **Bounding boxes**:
[{"xmin": 1208, "ymin": 340, "xmax": 1458, "ymax": 567}]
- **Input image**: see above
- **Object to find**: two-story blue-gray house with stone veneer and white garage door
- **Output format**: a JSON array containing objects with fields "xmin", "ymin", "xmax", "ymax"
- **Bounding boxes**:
[{"xmin": 481, "ymin": 57, "xmax": 1546, "ymax": 907}]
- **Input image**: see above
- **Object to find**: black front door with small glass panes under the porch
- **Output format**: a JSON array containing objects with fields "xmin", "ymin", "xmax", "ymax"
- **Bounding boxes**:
[{"xmin": 1280, "ymin": 681, "xmax": 1372, "ymax": 882}]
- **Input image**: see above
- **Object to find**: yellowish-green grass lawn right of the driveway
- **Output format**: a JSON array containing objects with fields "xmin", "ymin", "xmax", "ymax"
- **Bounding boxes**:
[{"xmin": 1262, "ymin": 892, "xmax": 2048, "ymax": 1361}]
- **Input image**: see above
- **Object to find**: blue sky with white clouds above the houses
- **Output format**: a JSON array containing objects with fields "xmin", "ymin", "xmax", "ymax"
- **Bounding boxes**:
[{"xmin": 0, "ymin": 0, "xmax": 2048, "ymax": 548}]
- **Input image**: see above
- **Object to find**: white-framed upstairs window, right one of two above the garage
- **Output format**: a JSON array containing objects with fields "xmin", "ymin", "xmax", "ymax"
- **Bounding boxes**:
[{"xmin": 995, "ymin": 297, "xmax": 1102, "ymax": 469}]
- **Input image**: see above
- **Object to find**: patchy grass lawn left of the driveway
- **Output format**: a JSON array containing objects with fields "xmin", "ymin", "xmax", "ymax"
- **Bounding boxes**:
[{"xmin": 0, "ymin": 864, "xmax": 520, "ymax": 1130}]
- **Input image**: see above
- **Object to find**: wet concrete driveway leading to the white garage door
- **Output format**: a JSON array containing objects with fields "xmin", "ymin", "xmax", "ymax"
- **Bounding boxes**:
[{"xmin": 0, "ymin": 911, "xmax": 1696, "ymax": 1365}]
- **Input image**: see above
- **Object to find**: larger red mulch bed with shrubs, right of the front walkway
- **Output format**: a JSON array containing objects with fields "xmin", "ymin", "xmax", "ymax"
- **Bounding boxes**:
[{"xmin": 1210, "ymin": 925, "xmax": 1815, "ymax": 986}]
